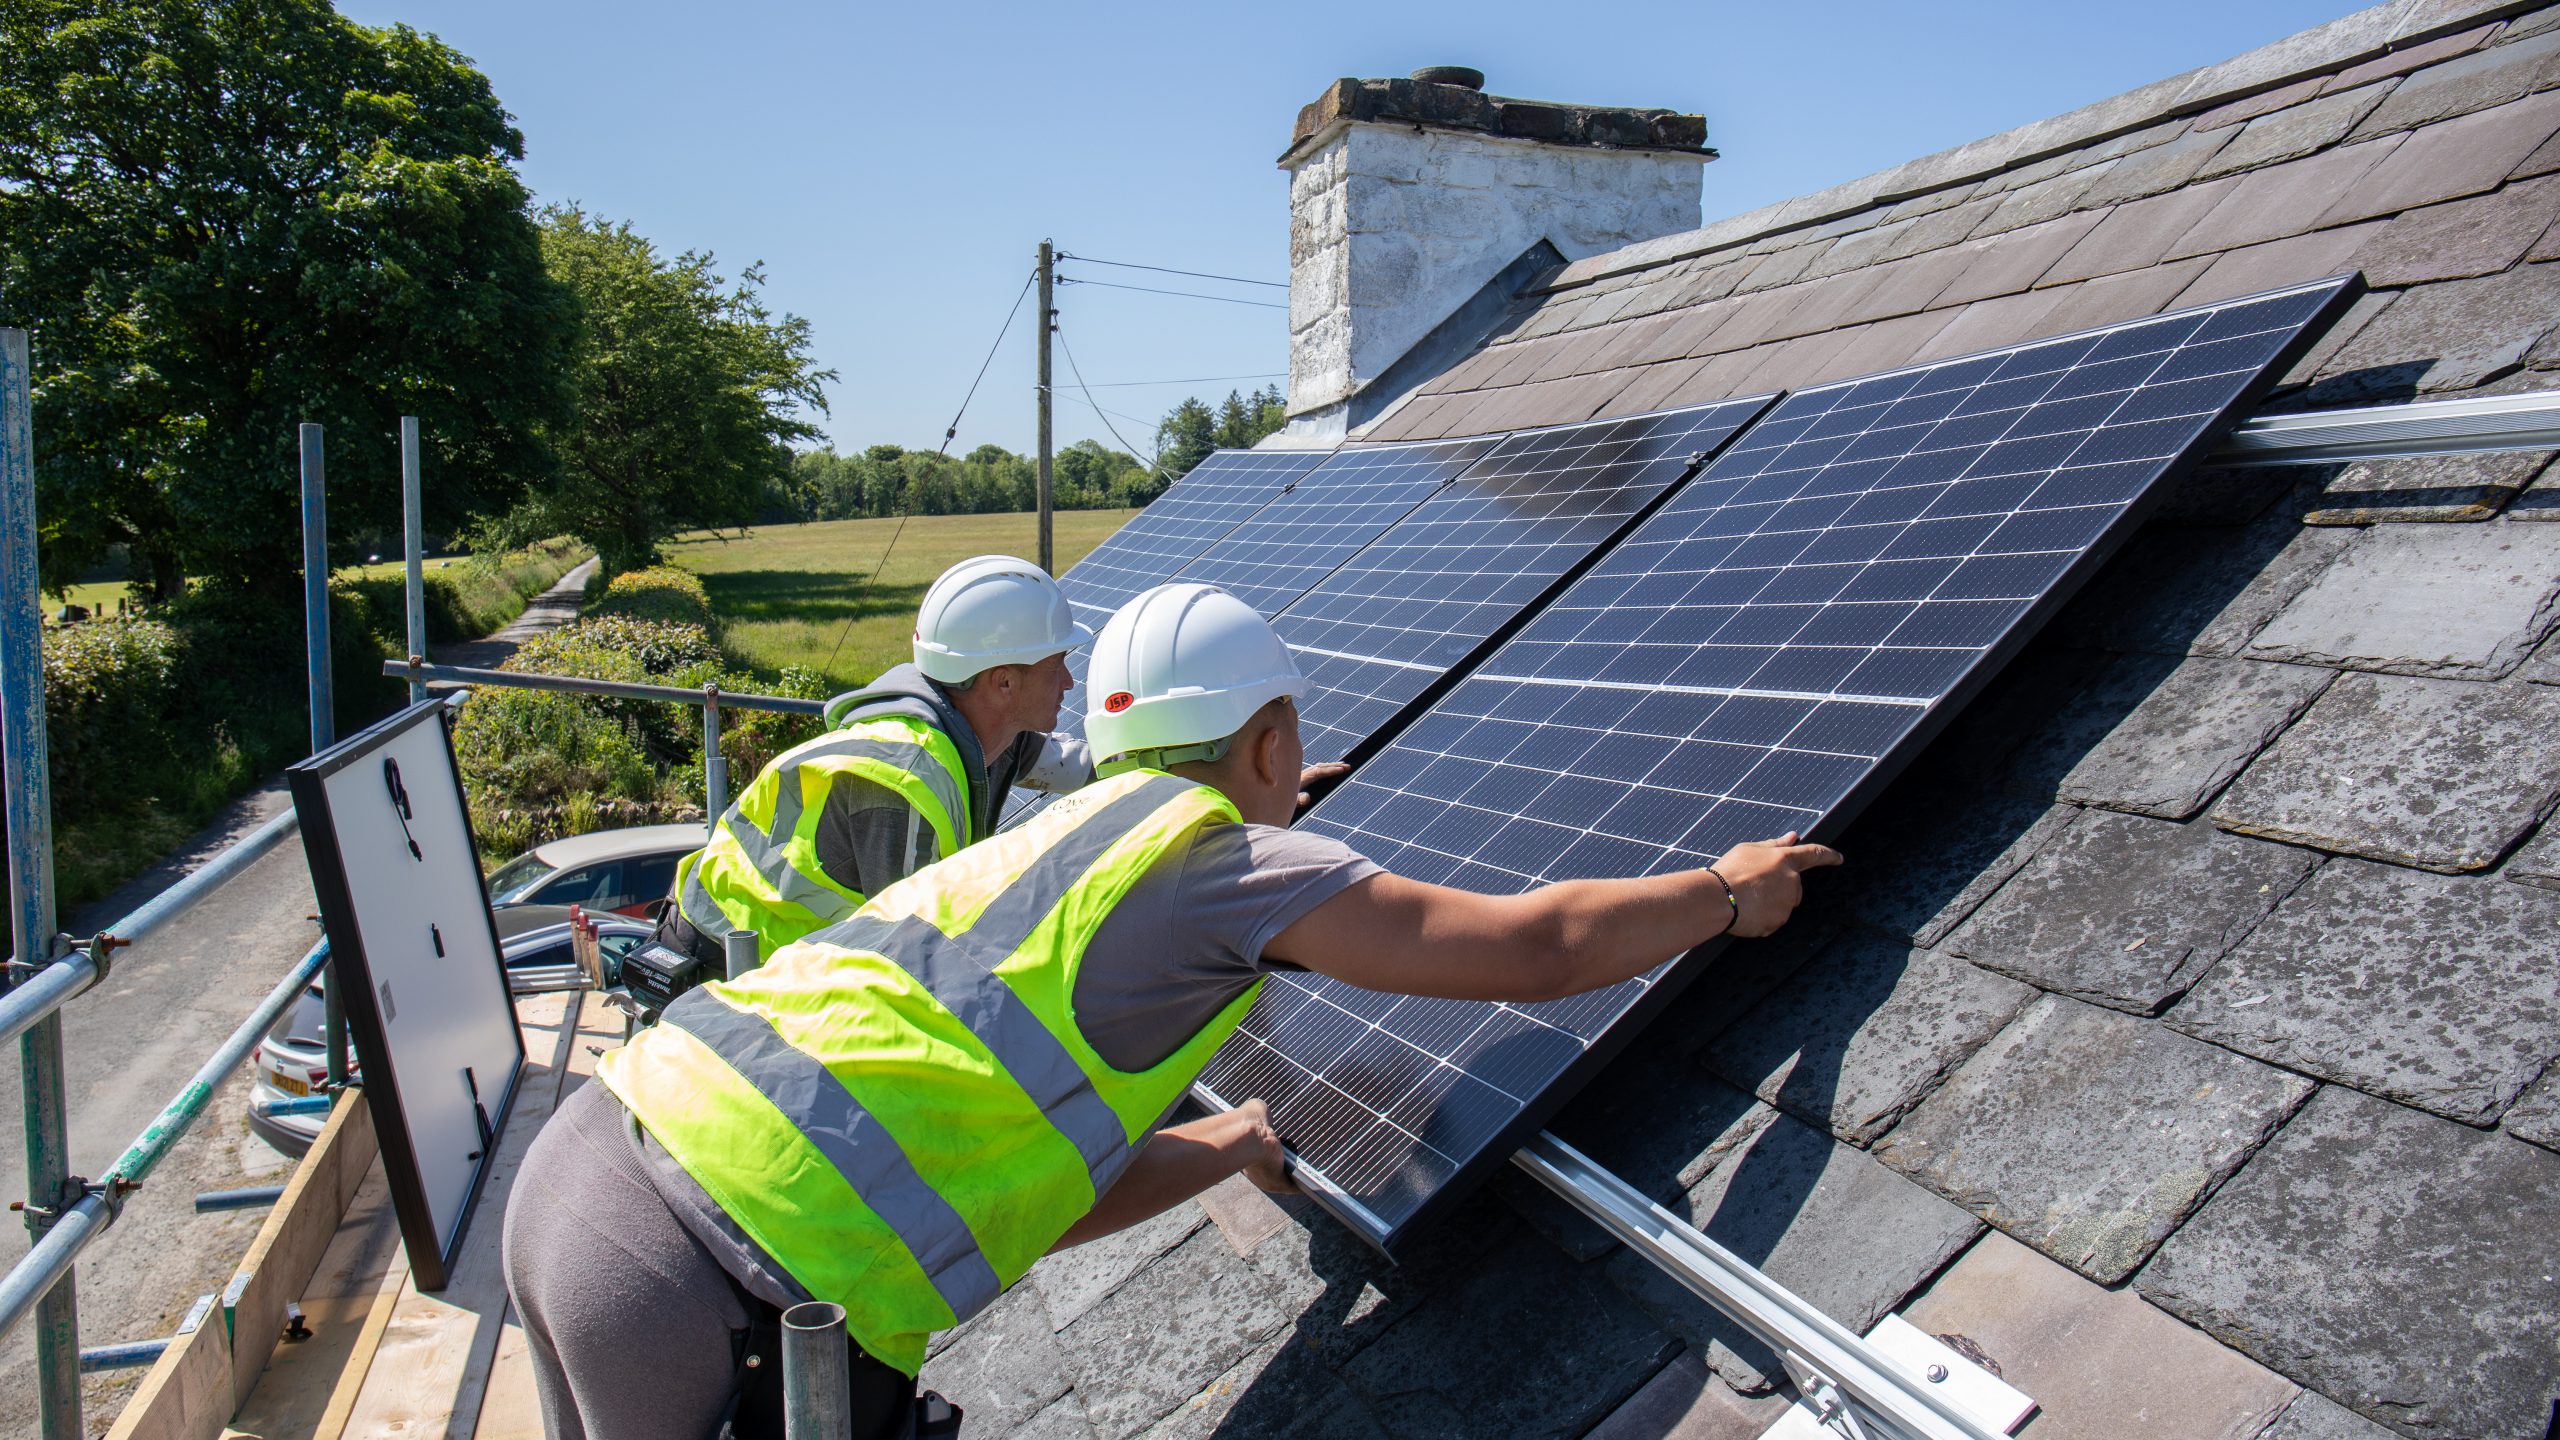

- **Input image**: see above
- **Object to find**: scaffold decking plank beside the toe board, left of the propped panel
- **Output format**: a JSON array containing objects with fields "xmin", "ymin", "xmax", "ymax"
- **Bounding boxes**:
[{"xmin": 223, "ymin": 1158, "xmax": 410, "ymax": 1440}]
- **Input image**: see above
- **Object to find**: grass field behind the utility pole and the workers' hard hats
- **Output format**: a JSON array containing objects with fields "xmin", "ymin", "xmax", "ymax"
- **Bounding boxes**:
[{"xmin": 666, "ymin": 510, "xmax": 1137, "ymax": 687}]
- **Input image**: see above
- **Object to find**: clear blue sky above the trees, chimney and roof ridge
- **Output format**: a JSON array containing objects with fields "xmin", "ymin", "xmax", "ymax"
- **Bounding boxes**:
[{"xmin": 340, "ymin": 0, "xmax": 2353, "ymax": 454}]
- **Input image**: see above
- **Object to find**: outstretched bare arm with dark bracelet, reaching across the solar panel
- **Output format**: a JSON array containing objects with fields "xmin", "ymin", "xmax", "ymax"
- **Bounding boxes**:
[{"xmin": 1265, "ymin": 835, "xmax": 1841, "ymax": 1002}]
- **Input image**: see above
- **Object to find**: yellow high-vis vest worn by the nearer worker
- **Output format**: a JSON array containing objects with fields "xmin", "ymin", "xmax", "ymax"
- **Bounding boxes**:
[{"xmin": 596, "ymin": 771, "xmax": 1260, "ymax": 1373}]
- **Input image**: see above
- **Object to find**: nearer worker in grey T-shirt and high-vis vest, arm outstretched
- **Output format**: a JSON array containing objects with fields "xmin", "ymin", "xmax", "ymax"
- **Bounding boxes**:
[{"xmin": 507, "ymin": 584, "xmax": 1838, "ymax": 1440}]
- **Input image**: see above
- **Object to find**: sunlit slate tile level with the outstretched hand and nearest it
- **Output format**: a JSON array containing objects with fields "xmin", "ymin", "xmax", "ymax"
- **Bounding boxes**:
[{"xmin": 1946, "ymin": 810, "xmax": 2319, "ymax": 1015}]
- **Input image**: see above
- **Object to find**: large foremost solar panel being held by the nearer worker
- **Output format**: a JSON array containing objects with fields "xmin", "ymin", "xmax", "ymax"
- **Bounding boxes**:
[{"xmin": 1201, "ymin": 277, "xmax": 2360, "ymax": 1245}]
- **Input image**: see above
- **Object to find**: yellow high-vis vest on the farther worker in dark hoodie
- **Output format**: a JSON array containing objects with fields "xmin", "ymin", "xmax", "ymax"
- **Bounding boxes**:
[{"xmin": 676, "ymin": 715, "xmax": 975, "ymax": 958}]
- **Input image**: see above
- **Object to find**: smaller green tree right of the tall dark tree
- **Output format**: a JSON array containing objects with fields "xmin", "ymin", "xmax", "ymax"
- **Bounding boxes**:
[{"xmin": 507, "ymin": 208, "xmax": 835, "ymax": 571}]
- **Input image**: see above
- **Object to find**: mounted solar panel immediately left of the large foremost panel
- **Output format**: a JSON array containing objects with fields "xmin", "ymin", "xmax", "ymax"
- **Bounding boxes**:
[{"xmin": 1275, "ymin": 395, "xmax": 1777, "ymax": 761}]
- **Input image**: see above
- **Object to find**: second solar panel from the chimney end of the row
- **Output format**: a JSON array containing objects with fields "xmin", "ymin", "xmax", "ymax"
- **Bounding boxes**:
[{"xmin": 1170, "ymin": 438, "xmax": 1492, "ymax": 618}]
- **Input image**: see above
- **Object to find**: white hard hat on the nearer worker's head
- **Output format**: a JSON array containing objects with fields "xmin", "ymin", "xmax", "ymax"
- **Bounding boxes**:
[{"xmin": 1085, "ymin": 582, "xmax": 1306, "ymax": 769}]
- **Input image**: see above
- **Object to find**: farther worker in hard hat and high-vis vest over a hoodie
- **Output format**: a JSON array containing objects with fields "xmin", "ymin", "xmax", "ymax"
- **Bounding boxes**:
[{"xmin": 660, "ymin": 556, "xmax": 1093, "ymax": 974}]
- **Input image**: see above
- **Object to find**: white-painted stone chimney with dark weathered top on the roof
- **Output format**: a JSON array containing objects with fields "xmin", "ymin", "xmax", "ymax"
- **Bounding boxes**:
[{"xmin": 1280, "ymin": 67, "xmax": 1715, "ymax": 441}]
